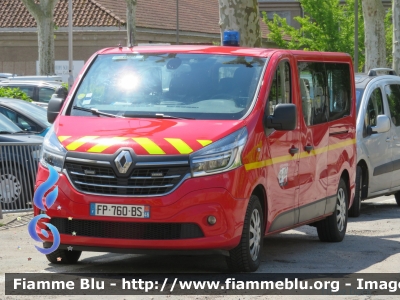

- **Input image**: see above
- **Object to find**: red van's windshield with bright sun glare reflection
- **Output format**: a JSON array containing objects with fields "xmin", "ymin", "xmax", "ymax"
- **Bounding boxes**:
[{"xmin": 71, "ymin": 53, "xmax": 266, "ymax": 120}]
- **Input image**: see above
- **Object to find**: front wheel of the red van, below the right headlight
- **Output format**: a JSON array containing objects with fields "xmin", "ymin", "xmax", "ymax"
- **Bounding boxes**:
[{"xmin": 226, "ymin": 195, "xmax": 264, "ymax": 272}]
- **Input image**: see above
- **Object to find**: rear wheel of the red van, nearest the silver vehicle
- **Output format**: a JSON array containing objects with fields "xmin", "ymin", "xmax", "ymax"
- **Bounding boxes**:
[{"xmin": 317, "ymin": 178, "xmax": 349, "ymax": 243}]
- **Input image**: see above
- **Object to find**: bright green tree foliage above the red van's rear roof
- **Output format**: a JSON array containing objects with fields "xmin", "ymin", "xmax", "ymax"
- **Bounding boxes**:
[{"xmin": 263, "ymin": 0, "xmax": 364, "ymax": 69}]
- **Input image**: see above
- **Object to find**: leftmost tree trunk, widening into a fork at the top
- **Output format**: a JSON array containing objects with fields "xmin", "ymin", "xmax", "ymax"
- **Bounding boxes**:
[{"xmin": 22, "ymin": 0, "xmax": 58, "ymax": 75}]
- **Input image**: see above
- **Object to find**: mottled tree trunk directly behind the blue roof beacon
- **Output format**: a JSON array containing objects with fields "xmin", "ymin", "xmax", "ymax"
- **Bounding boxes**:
[{"xmin": 218, "ymin": 0, "xmax": 261, "ymax": 47}]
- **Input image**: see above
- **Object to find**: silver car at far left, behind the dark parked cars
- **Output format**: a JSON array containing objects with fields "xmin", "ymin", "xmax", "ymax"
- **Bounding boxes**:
[{"xmin": 0, "ymin": 80, "xmax": 61, "ymax": 108}]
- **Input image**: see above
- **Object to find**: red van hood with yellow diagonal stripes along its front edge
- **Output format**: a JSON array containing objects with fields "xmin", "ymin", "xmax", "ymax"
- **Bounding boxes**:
[{"xmin": 54, "ymin": 116, "xmax": 245, "ymax": 155}]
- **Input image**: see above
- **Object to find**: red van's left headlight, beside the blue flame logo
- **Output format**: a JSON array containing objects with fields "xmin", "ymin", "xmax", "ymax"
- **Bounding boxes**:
[{"xmin": 40, "ymin": 126, "xmax": 67, "ymax": 172}]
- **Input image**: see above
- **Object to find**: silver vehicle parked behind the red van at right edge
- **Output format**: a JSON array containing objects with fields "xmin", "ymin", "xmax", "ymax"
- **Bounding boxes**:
[{"xmin": 349, "ymin": 68, "xmax": 400, "ymax": 217}]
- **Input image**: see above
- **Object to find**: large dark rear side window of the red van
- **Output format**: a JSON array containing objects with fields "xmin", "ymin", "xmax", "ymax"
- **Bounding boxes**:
[{"xmin": 298, "ymin": 62, "xmax": 351, "ymax": 126}]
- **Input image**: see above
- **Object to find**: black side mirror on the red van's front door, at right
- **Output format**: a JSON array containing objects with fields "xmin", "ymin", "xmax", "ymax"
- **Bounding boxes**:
[{"xmin": 264, "ymin": 103, "xmax": 297, "ymax": 130}]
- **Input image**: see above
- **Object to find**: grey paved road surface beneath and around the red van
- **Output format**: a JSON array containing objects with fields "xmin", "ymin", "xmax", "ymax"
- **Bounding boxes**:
[{"xmin": 0, "ymin": 196, "xmax": 400, "ymax": 299}]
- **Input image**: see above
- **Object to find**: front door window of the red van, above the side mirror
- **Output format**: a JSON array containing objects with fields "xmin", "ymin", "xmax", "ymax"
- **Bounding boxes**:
[{"xmin": 265, "ymin": 61, "xmax": 292, "ymax": 115}]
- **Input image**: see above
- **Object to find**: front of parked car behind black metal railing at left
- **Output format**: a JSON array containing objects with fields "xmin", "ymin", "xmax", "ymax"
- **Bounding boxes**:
[{"xmin": 0, "ymin": 114, "xmax": 43, "ymax": 210}]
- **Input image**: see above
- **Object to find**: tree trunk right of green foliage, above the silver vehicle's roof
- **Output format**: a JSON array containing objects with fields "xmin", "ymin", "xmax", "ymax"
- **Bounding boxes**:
[{"xmin": 362, "ymin": 0, "xmax": 386, "ymax": 72}]
